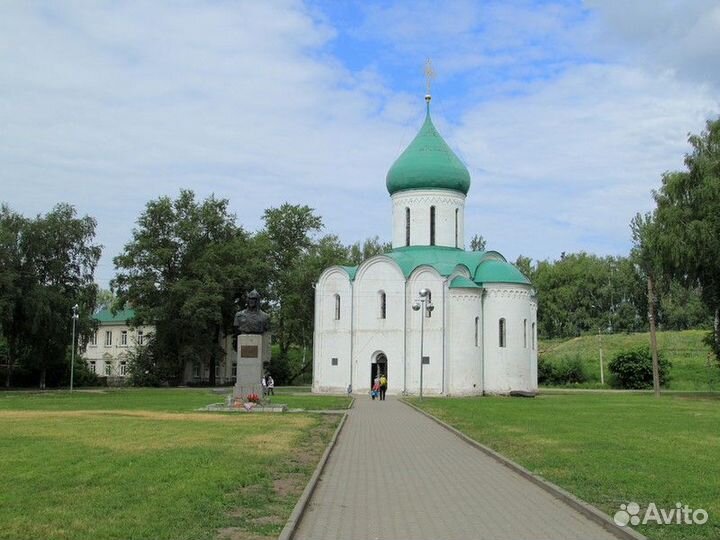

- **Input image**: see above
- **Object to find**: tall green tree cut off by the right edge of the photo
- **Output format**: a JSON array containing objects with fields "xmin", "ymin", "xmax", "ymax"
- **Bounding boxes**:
[{"xmin": 654, "ymin": 119, "xmax": 720, "ymax": 360}]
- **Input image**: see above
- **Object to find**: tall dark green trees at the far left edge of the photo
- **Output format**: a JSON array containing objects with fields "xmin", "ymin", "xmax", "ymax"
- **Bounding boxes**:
[{"xmin": 0, "ymin": 204, "xmax": 101, "ymax": 388}]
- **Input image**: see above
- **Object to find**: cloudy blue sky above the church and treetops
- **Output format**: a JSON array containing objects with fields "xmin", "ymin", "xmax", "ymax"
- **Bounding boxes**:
[{"xmin": 0, "ymin": 0, "xmax": 720, "ymax": 285}]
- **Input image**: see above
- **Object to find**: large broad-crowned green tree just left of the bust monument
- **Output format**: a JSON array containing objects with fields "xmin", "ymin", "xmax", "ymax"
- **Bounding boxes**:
[{"xmin": 111, "ymin": 190, "xmax": 267, "ymax": 384}]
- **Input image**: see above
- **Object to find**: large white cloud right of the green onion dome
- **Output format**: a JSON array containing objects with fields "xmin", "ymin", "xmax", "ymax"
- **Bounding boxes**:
[{"xmin": 454, "ymin": 65, "xmax": 718, "ymax": 258}]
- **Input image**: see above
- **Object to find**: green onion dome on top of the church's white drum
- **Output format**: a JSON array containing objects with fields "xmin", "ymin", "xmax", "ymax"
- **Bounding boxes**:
[{"xmin": 386, "ymin": 103, "xmax": 470, "ymax": 195}]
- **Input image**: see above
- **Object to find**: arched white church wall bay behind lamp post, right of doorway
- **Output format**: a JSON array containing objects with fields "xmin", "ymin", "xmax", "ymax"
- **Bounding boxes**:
[{"xmin": 405, "ymin": 266, "xmax": 445, "ymax": 394}]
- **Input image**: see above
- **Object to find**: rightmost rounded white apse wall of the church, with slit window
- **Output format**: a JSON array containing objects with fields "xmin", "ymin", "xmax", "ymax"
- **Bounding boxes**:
[{"xmin": 483, "ymin": 284, "xmax": 537, "ymax": 394}]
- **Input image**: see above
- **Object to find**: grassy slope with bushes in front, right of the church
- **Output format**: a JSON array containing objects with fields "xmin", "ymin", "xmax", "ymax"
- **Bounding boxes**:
[{"xmin": 539, "ymin": 330, "xmax": 720, "ymax": 390}]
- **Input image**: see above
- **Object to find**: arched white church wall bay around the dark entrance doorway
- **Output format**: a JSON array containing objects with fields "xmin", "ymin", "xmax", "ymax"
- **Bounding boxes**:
[{"xmin": 353, "ymin": 256, "xmax": 405, "ymax": 394}]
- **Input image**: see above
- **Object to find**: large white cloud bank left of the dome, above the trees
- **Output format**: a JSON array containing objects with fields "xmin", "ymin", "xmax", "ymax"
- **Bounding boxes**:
[{"xmin": 0, "ymin": 2, "xmax": 411, "ymax": 282}]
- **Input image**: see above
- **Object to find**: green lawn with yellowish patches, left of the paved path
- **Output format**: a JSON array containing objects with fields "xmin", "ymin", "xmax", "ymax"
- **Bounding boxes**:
[{"xmin": 0, "ymin": 389, "xmax": 339, "ymax": 540}]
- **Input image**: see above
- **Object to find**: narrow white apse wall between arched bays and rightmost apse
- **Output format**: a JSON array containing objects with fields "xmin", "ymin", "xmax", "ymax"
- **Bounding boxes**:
[{"xmin": 447, "ymin": 289, "xmax": 483, "ymax": 395}]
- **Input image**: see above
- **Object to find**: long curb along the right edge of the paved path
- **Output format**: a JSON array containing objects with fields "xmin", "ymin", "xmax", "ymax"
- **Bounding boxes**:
[{"xmin": 399, "ymin": 399, "xmax": 648, "ymax": 540}]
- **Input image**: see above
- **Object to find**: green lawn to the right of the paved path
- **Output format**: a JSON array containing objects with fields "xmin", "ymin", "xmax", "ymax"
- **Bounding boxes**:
[{"xmin": 411, "ymin": 393, "xmax": 720, "ymax": 540}]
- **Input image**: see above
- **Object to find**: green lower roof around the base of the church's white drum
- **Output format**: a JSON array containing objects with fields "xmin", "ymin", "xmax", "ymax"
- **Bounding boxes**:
[{"xmin": 382, "ymin": 246, "xmax": 530, "ymax": 288}]
